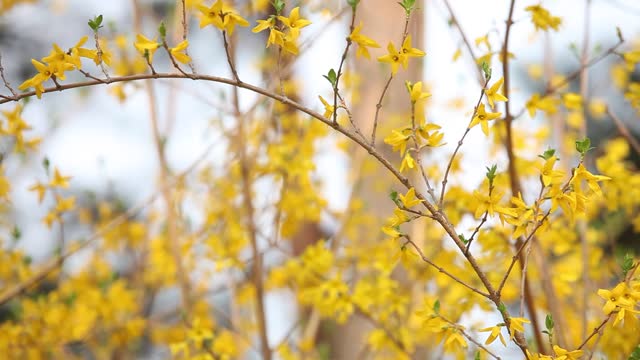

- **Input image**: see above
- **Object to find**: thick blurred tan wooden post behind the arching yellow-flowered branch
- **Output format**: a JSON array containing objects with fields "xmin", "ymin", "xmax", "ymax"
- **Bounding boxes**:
[{"xmin": 330, "ymin": 0, "xmax": 425, "ymax": 360}]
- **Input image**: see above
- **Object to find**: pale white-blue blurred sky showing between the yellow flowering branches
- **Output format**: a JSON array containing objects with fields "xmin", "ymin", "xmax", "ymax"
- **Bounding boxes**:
[{"xmin": 0, "ymin": 0, "xmax": 640, "ymax": 358}]
